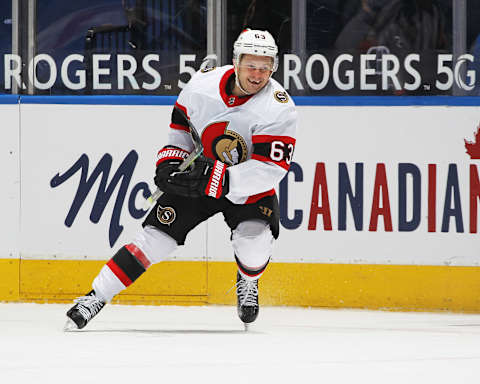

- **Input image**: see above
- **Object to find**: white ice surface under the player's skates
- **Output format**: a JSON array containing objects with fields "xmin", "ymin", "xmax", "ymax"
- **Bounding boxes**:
[{"xmin": 0, "ymin": 304, "xmax": 480, "ymax": 384}]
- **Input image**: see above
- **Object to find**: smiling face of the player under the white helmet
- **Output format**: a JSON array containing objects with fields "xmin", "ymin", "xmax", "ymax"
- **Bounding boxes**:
[{"xmin": 233, "ymin": 55, "xmax": 273, "ymax": 94}]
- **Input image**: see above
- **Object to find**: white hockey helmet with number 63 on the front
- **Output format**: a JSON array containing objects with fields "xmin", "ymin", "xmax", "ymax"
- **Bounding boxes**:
[{"xmin": 233, "ymin": 29, "xmax": 278, "ymax": 72}]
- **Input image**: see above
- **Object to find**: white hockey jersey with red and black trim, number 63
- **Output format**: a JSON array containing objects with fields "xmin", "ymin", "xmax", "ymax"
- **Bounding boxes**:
[{"xmin": 168, "ymin": 65, "xmax": 297, "ymax": 204}]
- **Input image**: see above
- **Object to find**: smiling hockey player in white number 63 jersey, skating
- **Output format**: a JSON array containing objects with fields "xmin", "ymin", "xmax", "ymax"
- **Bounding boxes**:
[{"xmin": 66, "ymin": 30, "xmax": 297, "ymax": 330}]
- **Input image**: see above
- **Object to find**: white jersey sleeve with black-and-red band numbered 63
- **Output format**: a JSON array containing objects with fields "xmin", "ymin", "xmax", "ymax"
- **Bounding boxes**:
[{"xmin": 226, "ymin": 106, "xmax": 297, "ymax": 204}]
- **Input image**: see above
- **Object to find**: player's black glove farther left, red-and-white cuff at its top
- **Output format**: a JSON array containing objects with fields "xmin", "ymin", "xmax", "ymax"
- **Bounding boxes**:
[{"xmin": 153, "ymin": 145, "xmax": 189, "ymax": 195}]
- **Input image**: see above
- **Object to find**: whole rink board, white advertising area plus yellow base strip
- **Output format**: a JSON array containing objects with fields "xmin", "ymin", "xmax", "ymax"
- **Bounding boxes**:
[{"xmin": 0, "ymin": 98, "xmax": 480, "ymax": 312}]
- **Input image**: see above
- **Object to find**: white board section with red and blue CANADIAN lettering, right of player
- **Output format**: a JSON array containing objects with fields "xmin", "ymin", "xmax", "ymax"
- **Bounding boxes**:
[{"xmin": 275, "ymin": 107, "xmax": 480, "ymax": 265}]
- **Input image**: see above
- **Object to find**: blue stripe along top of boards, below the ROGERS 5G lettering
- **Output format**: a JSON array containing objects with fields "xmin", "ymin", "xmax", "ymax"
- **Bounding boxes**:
[{"xmin": 0, "ymin": 95, "xmax": 480, "ymax": 107}]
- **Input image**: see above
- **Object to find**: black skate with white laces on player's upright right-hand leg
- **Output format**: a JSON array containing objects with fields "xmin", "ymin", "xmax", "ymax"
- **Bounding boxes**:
[{"xmin": 237, "ymin": 272, "xmax": 260, "ymax": 330}]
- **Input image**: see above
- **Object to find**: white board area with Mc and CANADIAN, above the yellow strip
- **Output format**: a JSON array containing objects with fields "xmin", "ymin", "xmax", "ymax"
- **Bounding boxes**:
[{"xmin": 16, "ymin": 105, "xmax": 480, "ymax": 266}]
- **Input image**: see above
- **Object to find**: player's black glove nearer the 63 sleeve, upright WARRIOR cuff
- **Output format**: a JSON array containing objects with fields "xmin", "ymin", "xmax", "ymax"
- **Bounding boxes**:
[{"xmin": 167, "ymin": 155, "xmax": 229, "ymax": 199}]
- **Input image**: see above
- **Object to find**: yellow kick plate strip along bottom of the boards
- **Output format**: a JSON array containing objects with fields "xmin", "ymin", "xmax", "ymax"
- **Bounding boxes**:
[{"xmin": 0, "ymin": 260, "xmax": 480, "ymax": 312}]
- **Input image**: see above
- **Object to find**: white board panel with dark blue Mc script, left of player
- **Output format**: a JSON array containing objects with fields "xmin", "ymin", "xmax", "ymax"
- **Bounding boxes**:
[{"xmin": 21, "ymin": 104, "xmax": 206, "ymax": 260}]
